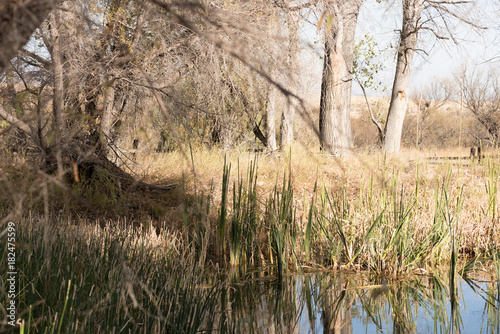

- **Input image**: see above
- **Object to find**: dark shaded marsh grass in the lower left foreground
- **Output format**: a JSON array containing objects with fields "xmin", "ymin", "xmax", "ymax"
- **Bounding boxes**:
[{"xmin": 0, "ymin": 217, "xmax": 230, "ymax": 333}]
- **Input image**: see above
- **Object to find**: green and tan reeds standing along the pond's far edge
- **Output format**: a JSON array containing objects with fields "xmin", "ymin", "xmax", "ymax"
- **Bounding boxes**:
[{"xmin": 173, "ymin": 147, "xmax": 499, "ymax": 282}]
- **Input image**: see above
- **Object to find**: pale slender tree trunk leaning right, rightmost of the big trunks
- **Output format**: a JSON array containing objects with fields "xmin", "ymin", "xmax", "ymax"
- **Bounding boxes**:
[{"xmin": 384, "ymin": 0, "xmax": 424, "ymax": 154}]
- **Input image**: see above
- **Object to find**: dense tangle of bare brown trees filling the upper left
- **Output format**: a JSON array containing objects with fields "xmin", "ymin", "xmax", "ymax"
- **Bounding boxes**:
[{"xmin": 2, "ymin": 1, "xmax": 298, "ymax": 165}]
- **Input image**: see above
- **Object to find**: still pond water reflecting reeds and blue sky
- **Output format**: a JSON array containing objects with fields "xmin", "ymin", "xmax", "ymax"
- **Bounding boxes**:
[{"xmin": 221, "ymin": 273, "xmax": 500, "ymax": 334}]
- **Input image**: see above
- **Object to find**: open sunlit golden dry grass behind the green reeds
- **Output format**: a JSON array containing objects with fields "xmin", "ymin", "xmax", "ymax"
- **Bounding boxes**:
[{"xmin": 136, "ymin": 145, "xmax": 500, "ymax": 254}]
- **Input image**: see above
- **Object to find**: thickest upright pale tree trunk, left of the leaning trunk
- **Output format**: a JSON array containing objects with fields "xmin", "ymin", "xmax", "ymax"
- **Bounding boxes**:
[{"xmin": 319, "ymin": 0, "xmax": 362, "ymax": 155}]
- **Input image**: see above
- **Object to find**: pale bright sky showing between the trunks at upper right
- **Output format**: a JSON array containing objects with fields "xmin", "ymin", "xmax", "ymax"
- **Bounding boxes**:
[{"xmin": 302, "ymin": 0, "xmax": 500, "ymax": 102}]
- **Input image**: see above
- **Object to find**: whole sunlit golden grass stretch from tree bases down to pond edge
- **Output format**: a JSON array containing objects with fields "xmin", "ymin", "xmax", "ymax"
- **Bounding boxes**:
[{"xmin": 127, "ymin": 146, "xmax": 499, "ymax": 272}]
